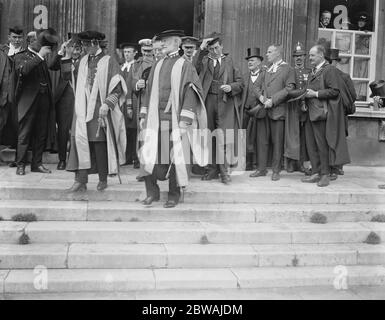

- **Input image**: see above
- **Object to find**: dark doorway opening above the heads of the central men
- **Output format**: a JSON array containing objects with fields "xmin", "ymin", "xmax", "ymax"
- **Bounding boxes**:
[{"xmin": 117, "ymin": 0, "xmax": 194, "ymax": 44}]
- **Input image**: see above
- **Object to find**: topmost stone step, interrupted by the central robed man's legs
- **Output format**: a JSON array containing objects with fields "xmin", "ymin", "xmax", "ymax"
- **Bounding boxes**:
[{"xmin": 0, "ymin": 182, "xmax": 385, "ymax": 206}]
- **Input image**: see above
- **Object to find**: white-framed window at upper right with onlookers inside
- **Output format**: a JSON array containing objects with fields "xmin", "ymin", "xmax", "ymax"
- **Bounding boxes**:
[{"xmin": 318, "ymin": 0, "xmax": 376, "ymax": 105}]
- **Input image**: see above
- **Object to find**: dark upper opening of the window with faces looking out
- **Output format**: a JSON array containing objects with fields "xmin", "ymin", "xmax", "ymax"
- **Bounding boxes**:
[{"xmin": 319, "ymin": 0, "xmax": 374, "ymax": 31}]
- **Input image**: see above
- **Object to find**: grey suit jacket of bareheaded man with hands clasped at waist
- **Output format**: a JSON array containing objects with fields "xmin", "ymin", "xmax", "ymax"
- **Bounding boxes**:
[{"xmin": 257, "ymin": 63, "xmax": 295, "ymax": 120}]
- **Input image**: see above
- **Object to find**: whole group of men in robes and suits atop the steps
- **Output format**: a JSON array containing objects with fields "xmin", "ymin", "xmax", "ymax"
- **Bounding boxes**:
[{"xmin": 0, "ymin": 29, "xmax": 364, "ymax": 208}]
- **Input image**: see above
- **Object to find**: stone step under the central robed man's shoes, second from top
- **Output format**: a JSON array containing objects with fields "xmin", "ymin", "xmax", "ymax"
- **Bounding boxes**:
[{"xmin": 0, "ymin": 200, "xmax": 385, "ymax": 223}]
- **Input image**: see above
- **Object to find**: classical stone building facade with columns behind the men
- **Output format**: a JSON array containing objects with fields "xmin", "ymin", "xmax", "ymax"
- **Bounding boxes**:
[{"xmin": 0, "ymin": 0, "xmax": 385, "ymax": 165}]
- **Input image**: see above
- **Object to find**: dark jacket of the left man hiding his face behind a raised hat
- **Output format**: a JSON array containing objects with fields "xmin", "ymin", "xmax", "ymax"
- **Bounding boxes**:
[{"xmin": 15, "ymin": 50, "xmax": 61, "ymax": 121}]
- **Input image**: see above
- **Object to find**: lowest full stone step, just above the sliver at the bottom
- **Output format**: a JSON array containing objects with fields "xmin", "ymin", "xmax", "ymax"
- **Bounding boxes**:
[{"xmin": 0, "ymin": 266, "xmax": 385, "ymax": 295}]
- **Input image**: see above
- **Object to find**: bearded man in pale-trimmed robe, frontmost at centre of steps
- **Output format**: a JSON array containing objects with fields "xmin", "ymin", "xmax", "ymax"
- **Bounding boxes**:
[{"xmin": 140, "ymin": 30, "xmax": 207, "ymax": 208}]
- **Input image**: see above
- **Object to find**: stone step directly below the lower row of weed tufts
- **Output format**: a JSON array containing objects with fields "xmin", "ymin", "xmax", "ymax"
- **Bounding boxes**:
[{"xmin": 0, "ymin": 243, "xmax": 385, "ymax": 269}]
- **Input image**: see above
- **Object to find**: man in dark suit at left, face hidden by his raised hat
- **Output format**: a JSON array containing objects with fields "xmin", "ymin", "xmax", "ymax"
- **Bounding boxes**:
[{"xmin": 15, "ymin": 29, "xmax": 62, "ymax": 175}]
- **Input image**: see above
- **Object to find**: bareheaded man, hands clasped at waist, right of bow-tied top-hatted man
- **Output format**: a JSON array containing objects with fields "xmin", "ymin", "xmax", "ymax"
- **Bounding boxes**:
[{"xmin": 257, "ymin": 45, "xmax": 299, "ymax": 181}]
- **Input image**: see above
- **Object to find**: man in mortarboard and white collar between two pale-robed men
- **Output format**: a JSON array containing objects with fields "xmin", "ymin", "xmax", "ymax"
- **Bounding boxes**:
[{"xmin": 120, "ymin": 43, "xmax": 138, "ymax": 166}]
